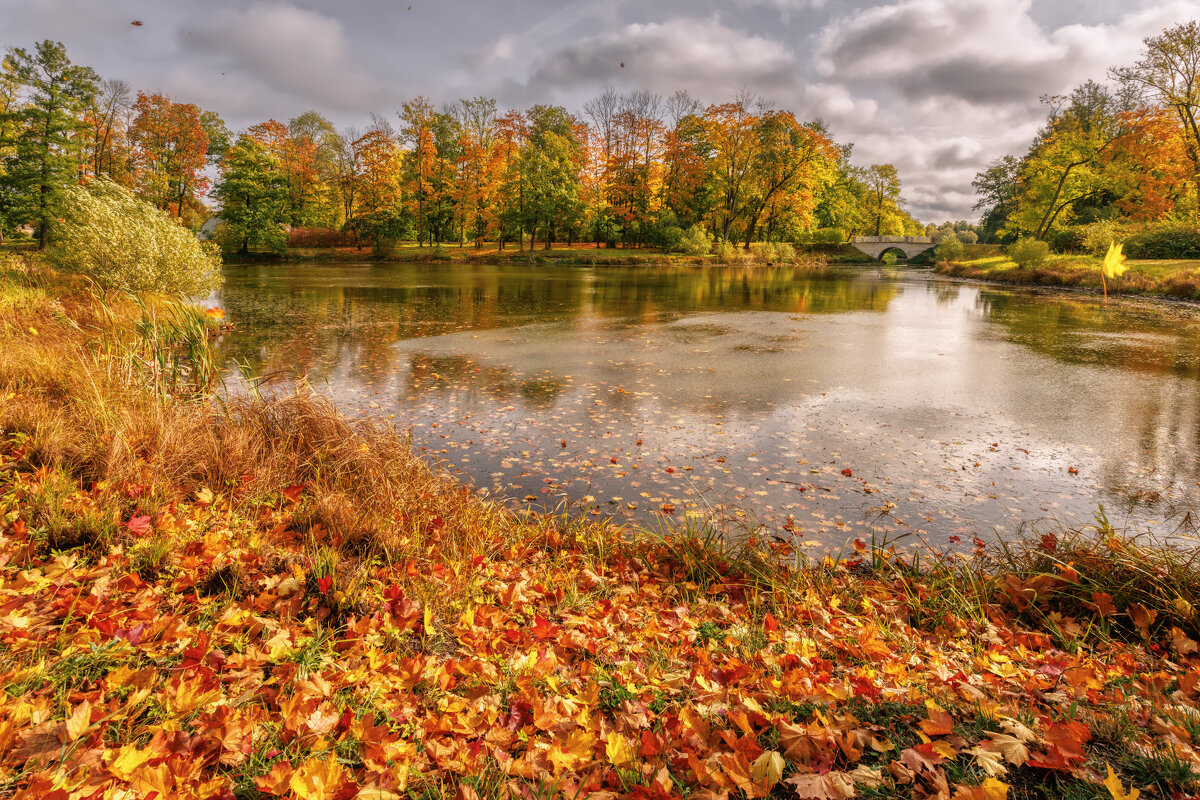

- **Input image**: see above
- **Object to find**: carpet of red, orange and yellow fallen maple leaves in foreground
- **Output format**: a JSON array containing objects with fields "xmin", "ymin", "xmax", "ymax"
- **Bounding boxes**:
[{"xmin": 0, "ymin": 424, "xmax": 1200, "ymax": 800}]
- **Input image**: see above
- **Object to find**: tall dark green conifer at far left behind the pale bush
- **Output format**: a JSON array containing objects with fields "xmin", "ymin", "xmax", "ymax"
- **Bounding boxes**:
[{"xmin": 0, "ymin": 40, "xmax": 100, "ymax": 249}]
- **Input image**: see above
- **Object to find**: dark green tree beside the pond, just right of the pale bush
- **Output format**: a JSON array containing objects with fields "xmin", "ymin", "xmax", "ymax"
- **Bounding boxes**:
[{"xmin": 212, "ymin": 136, "xmax": 288, "ymax": 254}]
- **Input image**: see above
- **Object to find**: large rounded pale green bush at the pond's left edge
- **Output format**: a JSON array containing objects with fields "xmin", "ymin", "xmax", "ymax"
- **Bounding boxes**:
[{"xmin": 48, "ymin": 179, "xmax": 221, "ymax": 296}]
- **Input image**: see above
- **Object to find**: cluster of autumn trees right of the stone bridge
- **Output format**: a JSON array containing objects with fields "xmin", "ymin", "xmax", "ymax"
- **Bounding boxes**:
[{"xmin": 973, "ymin": 20, "xmax": 1200, "ymax": 254}]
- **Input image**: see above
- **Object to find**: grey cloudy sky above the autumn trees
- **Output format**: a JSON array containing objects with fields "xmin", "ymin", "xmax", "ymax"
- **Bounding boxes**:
[{"xmin": 0, "ymin": 0, "xmax": 1200, "ymax": 222}]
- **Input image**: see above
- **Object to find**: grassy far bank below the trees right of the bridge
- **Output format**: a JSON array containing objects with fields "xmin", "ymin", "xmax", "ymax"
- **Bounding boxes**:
[{"xmin": 935, "ymin": 255, "xmax": 1200, "ymax": 300}]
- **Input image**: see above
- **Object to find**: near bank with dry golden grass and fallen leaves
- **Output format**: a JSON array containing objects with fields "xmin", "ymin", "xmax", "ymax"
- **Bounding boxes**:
[{"xmin": 0, "ymin": 263, "xmax": 1200, "ymax": 800}]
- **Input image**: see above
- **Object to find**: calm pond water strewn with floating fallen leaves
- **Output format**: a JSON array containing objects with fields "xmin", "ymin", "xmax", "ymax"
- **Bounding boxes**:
[{"xmin": 211, "ymin": 265, "xmax": 1200, "ymax": 547}]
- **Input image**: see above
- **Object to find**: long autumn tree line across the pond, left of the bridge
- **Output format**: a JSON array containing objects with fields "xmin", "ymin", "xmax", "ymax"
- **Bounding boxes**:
[{"xmin": 0, "ymin": 41, "xmax": 924, "ymax": 251}]
